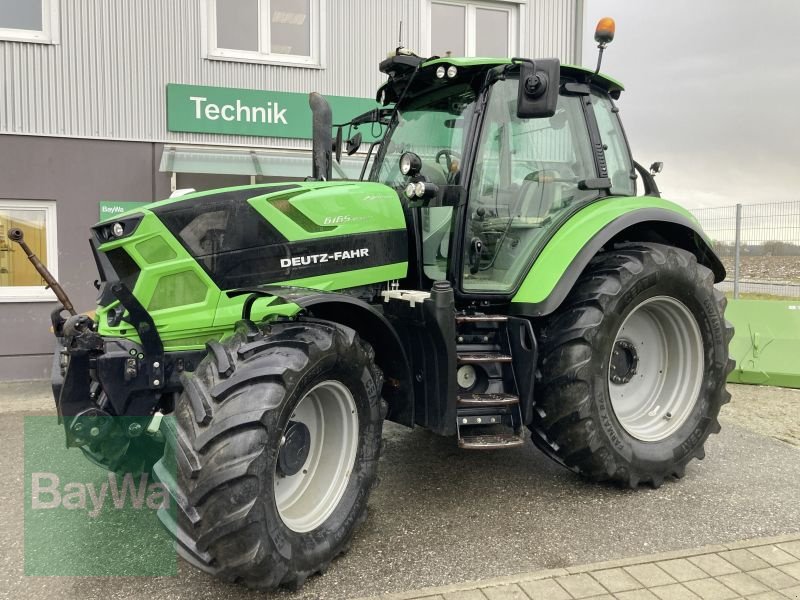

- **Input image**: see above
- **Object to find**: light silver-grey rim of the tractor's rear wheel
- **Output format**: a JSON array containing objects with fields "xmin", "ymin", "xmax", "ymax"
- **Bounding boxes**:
[{"xmin": 608, "ymin": 296, "xmax": 705, "ymax": 442}]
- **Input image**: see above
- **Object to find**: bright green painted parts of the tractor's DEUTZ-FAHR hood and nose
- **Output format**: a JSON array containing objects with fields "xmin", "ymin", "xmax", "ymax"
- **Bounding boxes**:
[{"xmin": 97, "ymin": 182, "xmax": 408, "ymax": 350}]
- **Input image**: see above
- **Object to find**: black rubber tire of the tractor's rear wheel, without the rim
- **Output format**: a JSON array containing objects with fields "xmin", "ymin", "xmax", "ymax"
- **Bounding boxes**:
[{"xmin": 530, "ymin": 243, "xmax": 734, "ymax": 488}]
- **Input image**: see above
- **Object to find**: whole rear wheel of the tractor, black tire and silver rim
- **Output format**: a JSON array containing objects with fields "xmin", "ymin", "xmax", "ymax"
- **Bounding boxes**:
[{"xmin": 531, "ymin": 244, "xmax": 733, "ymax": 487}]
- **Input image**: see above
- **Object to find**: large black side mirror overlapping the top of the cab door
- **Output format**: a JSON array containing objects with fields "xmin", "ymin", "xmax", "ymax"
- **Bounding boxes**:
[{"xmin": 513, "ymin": 58, "xmax": 561, "ymax": 119}]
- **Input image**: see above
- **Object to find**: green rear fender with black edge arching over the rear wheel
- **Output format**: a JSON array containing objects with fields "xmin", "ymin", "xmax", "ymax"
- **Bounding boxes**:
[{"xmin": 511, "ymin": 196, "xmax": 725, "ymax": 317}]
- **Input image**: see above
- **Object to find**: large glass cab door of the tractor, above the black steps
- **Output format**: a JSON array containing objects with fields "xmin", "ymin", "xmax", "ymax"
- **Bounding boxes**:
[{"xmin": 460, "ymin": 78, "xmax": 597, "ymax": 295}]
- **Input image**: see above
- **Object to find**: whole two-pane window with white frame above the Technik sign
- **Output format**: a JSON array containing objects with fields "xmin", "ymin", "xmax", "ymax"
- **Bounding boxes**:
[{"xmin": 208, "ymin": 0, "xmax": 326, "ymax": 66}]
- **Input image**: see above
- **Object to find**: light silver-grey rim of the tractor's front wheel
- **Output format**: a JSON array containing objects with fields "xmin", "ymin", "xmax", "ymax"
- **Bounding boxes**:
[{"xmin": 274, "ymin": 380, "xmax": 358, "ymax": 533}]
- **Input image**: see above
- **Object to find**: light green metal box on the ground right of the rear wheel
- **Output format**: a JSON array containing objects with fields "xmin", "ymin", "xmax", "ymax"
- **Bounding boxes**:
[{"xmin": 725, "ymin": 300, "xmax": 800, "ymax": 388}]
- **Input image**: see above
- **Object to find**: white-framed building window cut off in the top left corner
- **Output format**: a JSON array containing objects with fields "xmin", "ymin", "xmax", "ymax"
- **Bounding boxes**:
[{"xmin": 0, "ymin": 0, "xmax": 58, "ymax": 44}]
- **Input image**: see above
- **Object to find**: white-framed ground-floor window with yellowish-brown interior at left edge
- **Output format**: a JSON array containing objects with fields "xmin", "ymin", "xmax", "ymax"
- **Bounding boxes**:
[{"xmin": 0, "ymin": 200, "xmax": 58, "ymax": 302}]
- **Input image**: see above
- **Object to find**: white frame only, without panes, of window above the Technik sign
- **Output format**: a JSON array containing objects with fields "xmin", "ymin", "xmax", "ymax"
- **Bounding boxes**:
[{"xmin": 201, "ymin": 0, "xmax": 328, "ymax": 69}]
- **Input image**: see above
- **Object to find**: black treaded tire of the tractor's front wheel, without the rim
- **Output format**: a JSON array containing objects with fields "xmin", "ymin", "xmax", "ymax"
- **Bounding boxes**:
[{"xmin": 155, "ymin": 320, "xmax": 384, "ymax": 589}]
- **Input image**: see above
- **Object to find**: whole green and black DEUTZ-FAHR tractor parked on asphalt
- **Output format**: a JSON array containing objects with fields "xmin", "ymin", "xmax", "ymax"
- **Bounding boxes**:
[{"xmin": 15, "ymin": 18, "xmax": 733, "ymax": 589}]
